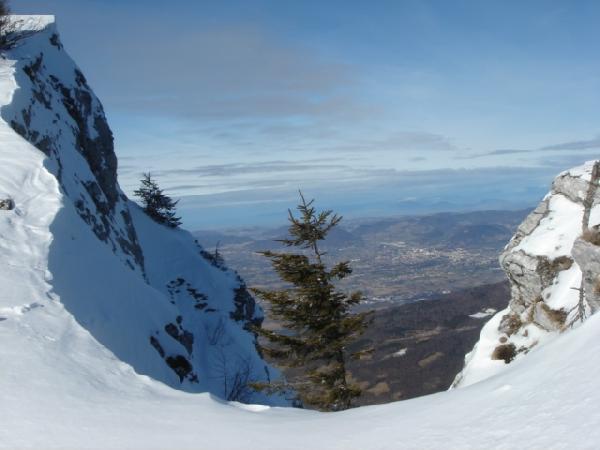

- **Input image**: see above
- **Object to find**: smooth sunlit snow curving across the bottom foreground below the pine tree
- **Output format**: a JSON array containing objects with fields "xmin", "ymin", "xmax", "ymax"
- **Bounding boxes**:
[{"xmin": 0, "ymin": 290, "xmax": 600, "ymax": 450}]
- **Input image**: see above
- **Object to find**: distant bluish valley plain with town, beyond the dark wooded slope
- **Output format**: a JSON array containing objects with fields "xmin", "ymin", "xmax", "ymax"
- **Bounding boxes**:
[{"xmin": 193, "ymin": 211, "xmax": 528, "ymax": 309}]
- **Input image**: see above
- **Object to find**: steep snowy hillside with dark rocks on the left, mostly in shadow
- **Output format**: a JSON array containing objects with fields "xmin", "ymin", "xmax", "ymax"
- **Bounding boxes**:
[{"xmin": 0, "ymin": 17, "xmax": 284, "ymax": 402}]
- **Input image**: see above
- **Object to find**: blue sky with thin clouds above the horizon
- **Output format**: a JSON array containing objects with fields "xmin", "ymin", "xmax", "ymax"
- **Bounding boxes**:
[{"xmin": 12, "ymin": 0, "xmax": 600, "ymax": 229}]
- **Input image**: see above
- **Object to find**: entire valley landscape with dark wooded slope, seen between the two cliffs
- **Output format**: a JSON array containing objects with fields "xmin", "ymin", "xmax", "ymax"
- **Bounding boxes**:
[{"xmin": 194, "ymin": 211, "xmax": 527, "ymax": 405}]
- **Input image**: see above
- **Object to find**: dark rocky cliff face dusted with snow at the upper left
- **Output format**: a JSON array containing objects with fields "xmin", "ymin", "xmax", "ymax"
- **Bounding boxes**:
[{"xmin": 1, "ymin": 16, "xmax": 144, "ymax": 272}]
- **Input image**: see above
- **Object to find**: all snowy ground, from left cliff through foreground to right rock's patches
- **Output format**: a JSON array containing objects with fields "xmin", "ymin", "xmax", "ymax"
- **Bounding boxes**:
[{"xmin": 0, "ymin": 17, "xmax": 600, "ymax": 450}]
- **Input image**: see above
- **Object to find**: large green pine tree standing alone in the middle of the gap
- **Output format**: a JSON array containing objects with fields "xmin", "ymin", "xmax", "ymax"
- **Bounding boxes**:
[{"xmin": 248, "ymin": 192, "xmax": 369, "ymax": 411}]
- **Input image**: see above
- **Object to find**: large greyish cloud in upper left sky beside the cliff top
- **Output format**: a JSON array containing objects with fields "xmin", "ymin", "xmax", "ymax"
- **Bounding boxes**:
[{"xmin": 79, "ymin": 17, "xmax": 368, "ymax": 121}]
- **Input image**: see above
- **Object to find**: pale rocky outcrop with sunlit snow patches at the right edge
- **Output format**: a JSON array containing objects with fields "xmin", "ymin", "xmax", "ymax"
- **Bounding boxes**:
[{"xmin": 454, "ymin": 161, "xmax": 600, "ymax": 386}]
